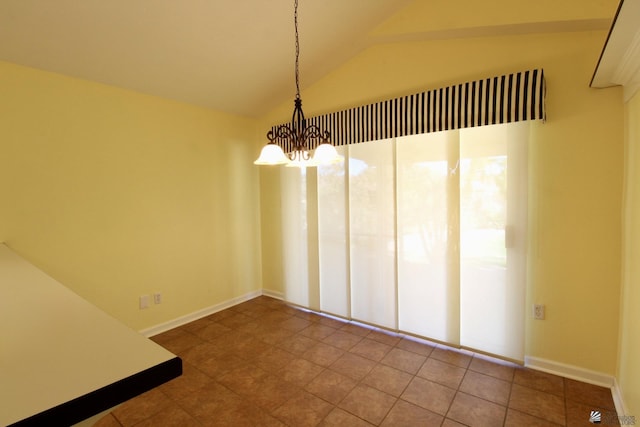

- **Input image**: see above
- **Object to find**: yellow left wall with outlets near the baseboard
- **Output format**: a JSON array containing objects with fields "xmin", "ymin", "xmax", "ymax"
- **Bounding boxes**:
[{"xmin": 0, "ymin": 63, "xmax": 261, "ymax": 329}]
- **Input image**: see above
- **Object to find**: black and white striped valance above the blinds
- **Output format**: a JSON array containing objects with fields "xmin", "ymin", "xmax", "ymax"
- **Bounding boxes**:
[{"xmin": 273, "ymin": 69, "xmax": 546, "ymax": 152}]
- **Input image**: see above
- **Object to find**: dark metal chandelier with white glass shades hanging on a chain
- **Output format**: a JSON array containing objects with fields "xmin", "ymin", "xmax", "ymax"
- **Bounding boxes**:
[{"xmin": 253, "ymin": 0, "xmax": 343, "ymax": 167}]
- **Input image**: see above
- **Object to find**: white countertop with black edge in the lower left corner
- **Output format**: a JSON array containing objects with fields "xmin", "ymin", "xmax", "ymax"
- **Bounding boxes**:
[{"xmin": 0, "ymin": 244, "xmax": 182, "ymax": 426}]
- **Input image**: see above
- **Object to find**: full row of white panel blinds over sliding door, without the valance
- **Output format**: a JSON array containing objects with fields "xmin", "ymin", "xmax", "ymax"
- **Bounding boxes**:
[{"xmin": 292, "ymin": 122, "xmax": 529, "ymax": 360}]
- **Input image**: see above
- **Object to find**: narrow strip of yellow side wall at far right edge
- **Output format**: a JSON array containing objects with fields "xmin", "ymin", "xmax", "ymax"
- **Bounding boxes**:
[{"xmin": 617, "ymin": 94, "xmax": 640, "ymax": 414}]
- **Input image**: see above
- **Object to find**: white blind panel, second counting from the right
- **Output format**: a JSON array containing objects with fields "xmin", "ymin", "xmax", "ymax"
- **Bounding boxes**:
[{"xmin": 396, "ymin": 132, "xmax": 460, "ymax": 344}]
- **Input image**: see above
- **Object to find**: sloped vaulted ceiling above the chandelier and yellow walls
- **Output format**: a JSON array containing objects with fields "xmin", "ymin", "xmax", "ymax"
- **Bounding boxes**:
[{"xmin": 0, "ymin": 0, "xmax": 617, "ymax": 117}]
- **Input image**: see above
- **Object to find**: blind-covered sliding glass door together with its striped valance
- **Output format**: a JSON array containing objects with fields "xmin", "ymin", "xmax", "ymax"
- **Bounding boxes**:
[{"xmin": 276, "ymin": 69, "xmax": 546, "ymax": 360}]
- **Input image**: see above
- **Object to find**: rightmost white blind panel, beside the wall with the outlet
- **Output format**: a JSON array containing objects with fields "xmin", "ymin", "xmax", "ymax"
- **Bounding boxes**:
[{"xmin": 460, "ymin": 123, "xmax": 528, "ymax": 360}]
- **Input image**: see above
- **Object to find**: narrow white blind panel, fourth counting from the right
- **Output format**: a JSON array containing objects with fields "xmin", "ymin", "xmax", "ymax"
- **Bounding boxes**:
[{"xmin": 318, "ymin": 147, "xmax": 350, "ymax": 318}]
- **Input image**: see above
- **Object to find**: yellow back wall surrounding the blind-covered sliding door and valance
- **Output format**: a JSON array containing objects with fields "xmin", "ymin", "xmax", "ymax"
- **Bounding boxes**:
[{"xmin": 261, "ymin": 30, "xmax": 623, "ymax": 375}]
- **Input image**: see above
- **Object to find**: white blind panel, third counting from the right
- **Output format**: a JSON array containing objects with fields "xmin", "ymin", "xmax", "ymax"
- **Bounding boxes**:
[{"xmin": 348, "ymin": 140, "xmax": 397, "ymax": 329}]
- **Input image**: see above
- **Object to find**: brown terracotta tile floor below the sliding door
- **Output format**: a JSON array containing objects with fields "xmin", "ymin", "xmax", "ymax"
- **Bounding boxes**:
[{"xmin": 96, "ymin": 297, "xmax": 615, "ymax": 427}]
